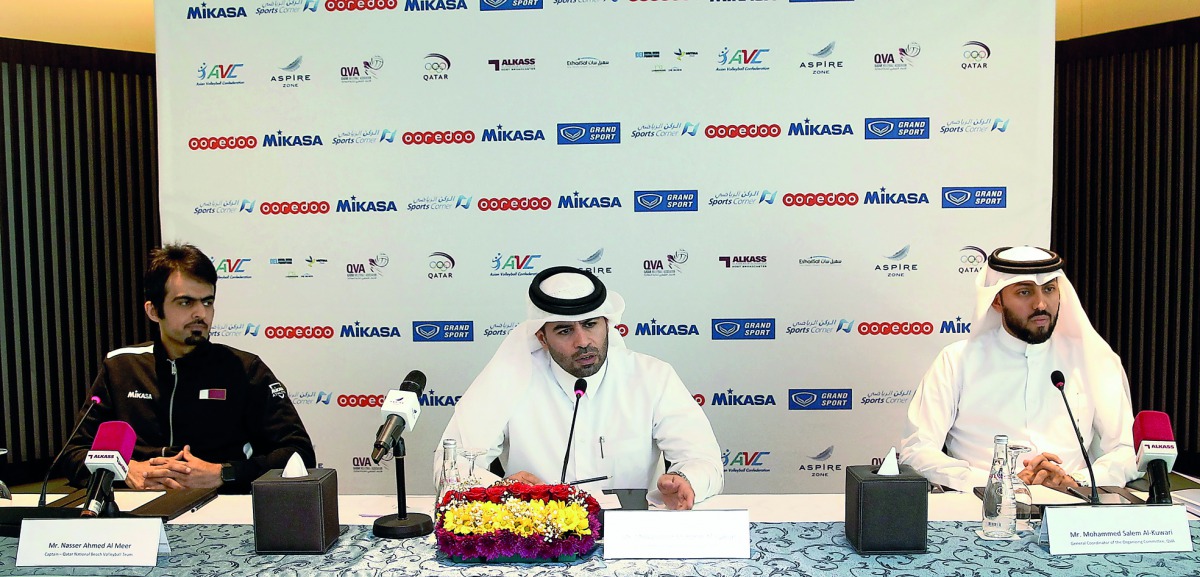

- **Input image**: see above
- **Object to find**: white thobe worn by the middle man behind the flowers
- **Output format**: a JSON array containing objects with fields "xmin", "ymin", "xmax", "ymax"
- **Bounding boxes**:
[{"xmin": 434, "ymin": 347, "xmax": 724, "ymax": 503}]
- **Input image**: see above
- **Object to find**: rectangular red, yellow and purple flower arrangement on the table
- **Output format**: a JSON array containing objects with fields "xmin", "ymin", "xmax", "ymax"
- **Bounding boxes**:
[{"xmin": 434, "ymin": 482, "xmax": 600, "ymax": 561}]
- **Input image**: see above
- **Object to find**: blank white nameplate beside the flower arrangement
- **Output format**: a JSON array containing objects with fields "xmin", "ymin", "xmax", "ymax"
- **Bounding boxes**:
[{"xmin": 604, "ymin": 510, "xmax": 750, "ymax": 559}]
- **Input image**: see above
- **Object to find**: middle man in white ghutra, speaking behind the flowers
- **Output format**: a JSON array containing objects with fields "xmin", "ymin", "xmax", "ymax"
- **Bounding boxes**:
[{"xmin": 434, "ymin": 266, "xmax": 724, "ymax": 509}]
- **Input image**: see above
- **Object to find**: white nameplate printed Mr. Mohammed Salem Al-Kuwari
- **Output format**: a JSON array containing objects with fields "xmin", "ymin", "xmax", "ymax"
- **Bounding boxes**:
[{"xmin": 1038, "ymin": 505, "xmax": 1192, "ymax": 555}]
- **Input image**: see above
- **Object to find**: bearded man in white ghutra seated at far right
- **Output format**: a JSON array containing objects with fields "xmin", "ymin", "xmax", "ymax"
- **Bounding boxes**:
[{"xmin": 900, "ymin": 246, "xmax": 1138, "ymax": 491}]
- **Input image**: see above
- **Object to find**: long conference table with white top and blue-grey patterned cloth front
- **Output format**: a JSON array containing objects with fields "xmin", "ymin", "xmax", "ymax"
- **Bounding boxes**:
[{"xmin": 0, "ymin": 493, "xmax": 1200, "ymax": 577}]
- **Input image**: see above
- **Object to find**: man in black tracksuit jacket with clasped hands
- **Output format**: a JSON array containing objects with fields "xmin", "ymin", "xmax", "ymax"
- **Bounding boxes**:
[{"xmin": 62, "ymin": 245, "xmax": 317, "ymax": 493}]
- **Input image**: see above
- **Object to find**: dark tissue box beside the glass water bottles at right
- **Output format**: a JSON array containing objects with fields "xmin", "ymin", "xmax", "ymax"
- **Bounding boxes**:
[{"xmin": 846, "ymin": 464, "xmax": 929, "ymax": 554}]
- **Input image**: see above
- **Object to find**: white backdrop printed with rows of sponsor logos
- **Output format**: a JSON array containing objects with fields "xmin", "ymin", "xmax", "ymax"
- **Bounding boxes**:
[{"xmin": 155, "ymin": 0, "xmax": 1054, "ymax": 493}]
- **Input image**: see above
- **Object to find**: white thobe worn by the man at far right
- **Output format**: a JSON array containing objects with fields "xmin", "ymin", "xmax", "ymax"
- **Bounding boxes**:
[{"xmin": 900, "ymin": 327, "xmax": 1138, "ymax": 491}]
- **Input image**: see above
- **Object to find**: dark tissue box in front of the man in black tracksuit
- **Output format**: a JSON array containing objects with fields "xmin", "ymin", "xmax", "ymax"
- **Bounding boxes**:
[{"xmin": 251, "ymin": 469, "xmax": 338, "ymax": 553}]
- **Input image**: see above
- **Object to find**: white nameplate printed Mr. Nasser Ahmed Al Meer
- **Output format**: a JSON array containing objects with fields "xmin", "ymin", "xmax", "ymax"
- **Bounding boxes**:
[{"xmin": 17, "ymin": 517, "xmax": 170, "ymax": 567}]
